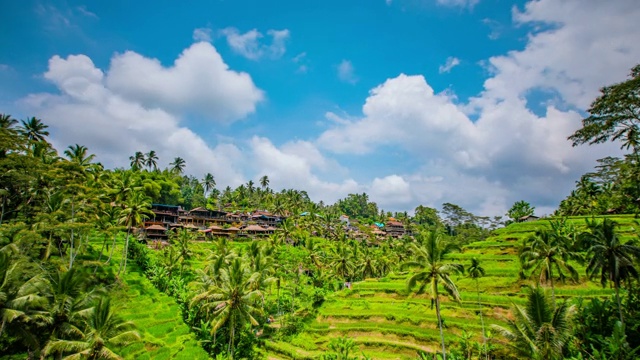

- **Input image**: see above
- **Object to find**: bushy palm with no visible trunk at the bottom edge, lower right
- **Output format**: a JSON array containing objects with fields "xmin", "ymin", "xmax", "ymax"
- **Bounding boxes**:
[{"xmin": 492, "ymin": 287, "xmax": 574, "ymax": 360}]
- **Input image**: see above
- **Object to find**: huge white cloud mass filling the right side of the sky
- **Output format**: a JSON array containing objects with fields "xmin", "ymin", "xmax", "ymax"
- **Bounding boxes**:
[{"xmin": 317, "ymin": 0, "xmax": 640, "ymax": 214}]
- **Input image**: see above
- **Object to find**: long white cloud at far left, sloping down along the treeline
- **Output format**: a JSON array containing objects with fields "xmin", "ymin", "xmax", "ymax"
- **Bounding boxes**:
[{"xmin": 23, "ymin": 55, "xmax": 248, "ymax": 184}]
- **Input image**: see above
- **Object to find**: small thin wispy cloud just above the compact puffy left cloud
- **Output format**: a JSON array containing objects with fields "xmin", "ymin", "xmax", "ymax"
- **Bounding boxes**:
[{"xmin": 220, "ymin": 27, "xmax": 291, "ymax": 60}]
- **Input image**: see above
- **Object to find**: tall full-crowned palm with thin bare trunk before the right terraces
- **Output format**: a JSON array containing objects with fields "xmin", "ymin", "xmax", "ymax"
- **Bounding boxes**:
[{"xmin": 403, "ymin": 231, "xmax": 464, "ymax": 360}]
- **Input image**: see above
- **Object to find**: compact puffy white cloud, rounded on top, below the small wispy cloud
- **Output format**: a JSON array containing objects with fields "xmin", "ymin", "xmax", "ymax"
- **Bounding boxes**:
[{"xmin": 106, "ymin": 42, "xmax": 264, "ymax": 123}]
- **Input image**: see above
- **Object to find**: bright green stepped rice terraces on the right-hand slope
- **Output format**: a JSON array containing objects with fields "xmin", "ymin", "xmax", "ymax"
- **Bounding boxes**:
[{"xmin": 266, "ymin": 215, "xmax": 639, "ymax": 359}]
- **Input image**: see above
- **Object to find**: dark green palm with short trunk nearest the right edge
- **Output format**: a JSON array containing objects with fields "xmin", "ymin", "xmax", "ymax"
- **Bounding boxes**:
[{"xmin": 580, "ymin": 219, "xmax": 640, "ymax": 324}]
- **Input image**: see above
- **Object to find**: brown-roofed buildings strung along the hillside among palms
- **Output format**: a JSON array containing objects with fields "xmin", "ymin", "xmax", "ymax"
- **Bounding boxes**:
[{"xmin": 144, "ymin": 204, "xmax": 409, "ymax": 241}]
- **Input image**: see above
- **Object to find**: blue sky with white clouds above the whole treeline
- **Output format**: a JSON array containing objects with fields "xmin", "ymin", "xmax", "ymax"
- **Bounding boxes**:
[{"xmin": 0, "ymin": 0, "xmax": 640, "ymax": 216}]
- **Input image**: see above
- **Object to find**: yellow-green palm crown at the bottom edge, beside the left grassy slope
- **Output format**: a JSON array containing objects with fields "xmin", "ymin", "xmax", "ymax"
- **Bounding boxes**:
[{"xmin": 44, "ymin": 298, "xmax": 140, "ymax": 360}]
